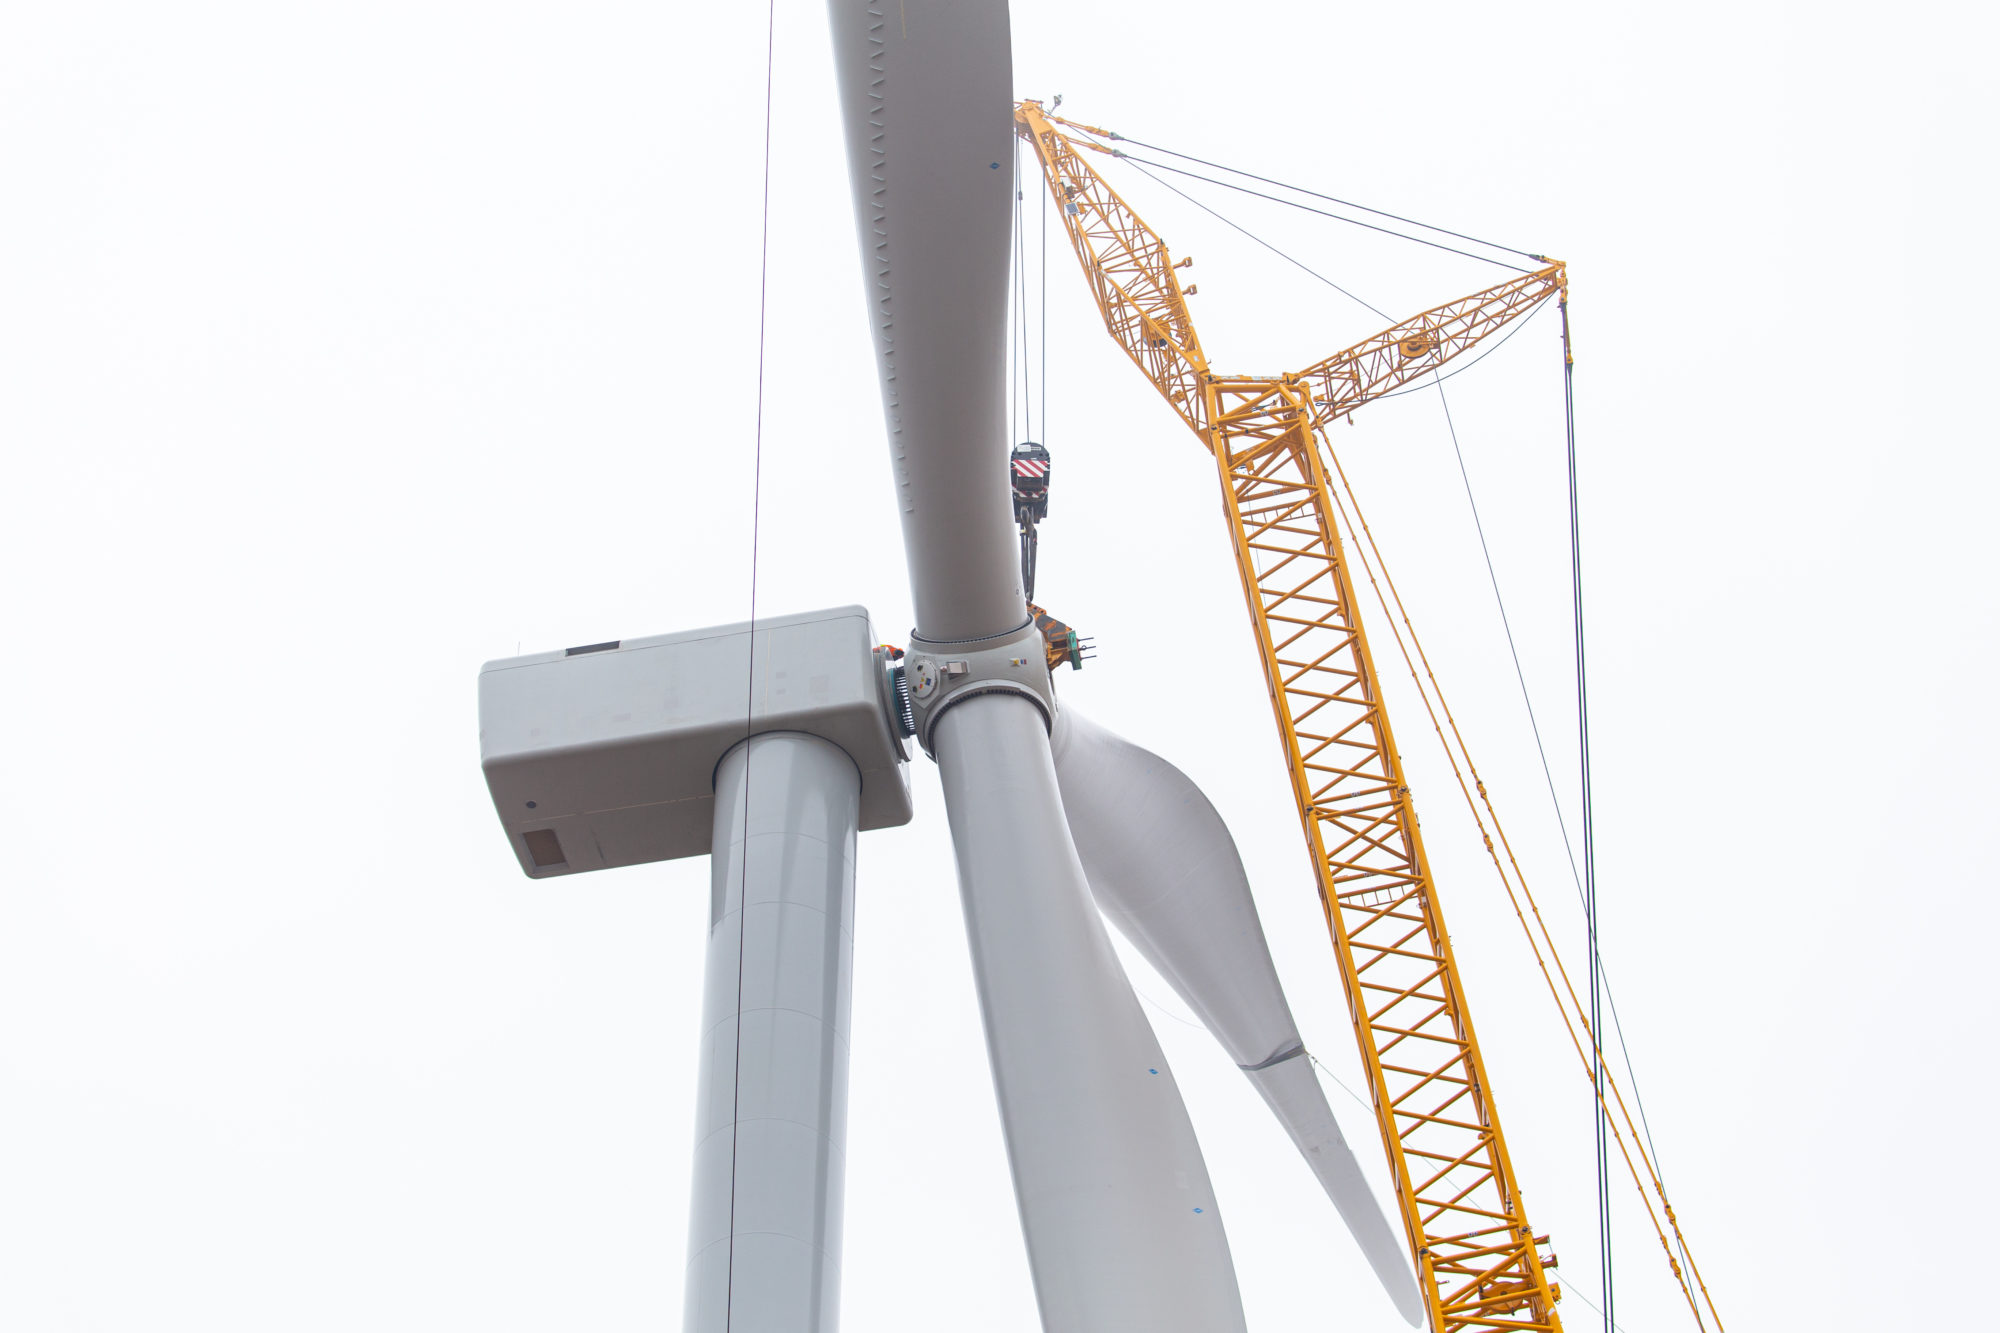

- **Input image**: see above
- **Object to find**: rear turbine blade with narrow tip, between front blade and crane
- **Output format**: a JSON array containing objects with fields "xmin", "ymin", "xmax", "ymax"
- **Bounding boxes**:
[{"xmin": 1052, "ymin": 707, "xmax": 1424, "ymax": 1325}]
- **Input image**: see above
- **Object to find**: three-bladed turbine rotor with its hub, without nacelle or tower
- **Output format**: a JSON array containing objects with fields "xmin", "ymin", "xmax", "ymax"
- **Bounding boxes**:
[{"xmin": 830, "ymin": 0, "xmax": 1422, "ymax": 1333}]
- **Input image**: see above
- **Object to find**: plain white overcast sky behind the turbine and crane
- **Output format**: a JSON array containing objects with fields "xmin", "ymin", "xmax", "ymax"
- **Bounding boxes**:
[{"xmin": 0, "ymin": 0, "xmax": 2000, "ymax": 1333}]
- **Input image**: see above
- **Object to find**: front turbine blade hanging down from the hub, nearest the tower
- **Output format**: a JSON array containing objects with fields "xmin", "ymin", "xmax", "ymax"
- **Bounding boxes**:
[{"xmin": 938, "ymin": 695, "xmax": 1244, "ymax": 1333}]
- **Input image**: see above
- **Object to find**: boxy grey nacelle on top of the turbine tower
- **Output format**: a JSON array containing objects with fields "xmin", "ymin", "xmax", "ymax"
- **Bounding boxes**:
[{"xmin": 480, "ymin": 606, "xmax": 912, "ymax": 879}]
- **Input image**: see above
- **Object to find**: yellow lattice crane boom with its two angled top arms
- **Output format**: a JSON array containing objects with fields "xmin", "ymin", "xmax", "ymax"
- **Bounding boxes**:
[{"xmin": 1016, "ymin": 102, "xmax": 1566, "ymax": 1333}]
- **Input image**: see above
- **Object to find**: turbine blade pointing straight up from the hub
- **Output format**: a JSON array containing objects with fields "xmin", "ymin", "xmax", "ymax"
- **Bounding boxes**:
[{"xmin": 828, "ymin": 0, "xmax": 1028, "ymax": 640}]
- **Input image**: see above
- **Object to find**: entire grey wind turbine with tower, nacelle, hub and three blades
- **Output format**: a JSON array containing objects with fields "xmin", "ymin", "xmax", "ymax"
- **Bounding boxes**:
[{"xmin": 480, "ymin": 0, "xmax": 1422, "ymax": 1333}]
